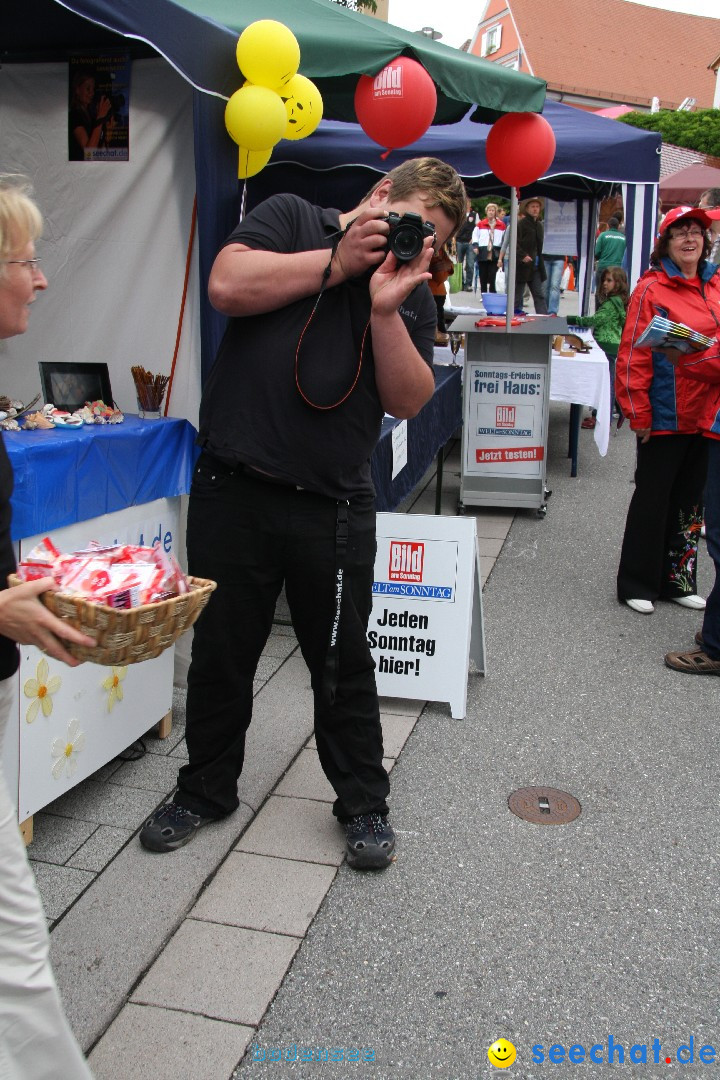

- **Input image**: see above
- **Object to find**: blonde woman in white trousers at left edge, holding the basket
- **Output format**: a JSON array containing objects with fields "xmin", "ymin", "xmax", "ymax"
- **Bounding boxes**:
[{"xmin": 0, "ymin": 175, "xmax": 93, "ymax": 1080}]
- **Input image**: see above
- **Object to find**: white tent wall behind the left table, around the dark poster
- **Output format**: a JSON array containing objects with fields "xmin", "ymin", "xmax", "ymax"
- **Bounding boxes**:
[{"xmin": 0, "ymin": 59, "xmax": 201, "ymax": 426}]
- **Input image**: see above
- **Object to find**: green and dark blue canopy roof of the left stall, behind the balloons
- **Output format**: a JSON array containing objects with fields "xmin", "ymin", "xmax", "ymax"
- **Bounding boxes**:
[{"xmin": 0, "ymin": 0, "xmax": 545, "ymax": 123}]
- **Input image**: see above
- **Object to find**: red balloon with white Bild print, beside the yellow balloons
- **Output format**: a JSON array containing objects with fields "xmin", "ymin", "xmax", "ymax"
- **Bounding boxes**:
[{"xmin": 355, "ymin": 56, "xmax": 437, "ymax": 150}]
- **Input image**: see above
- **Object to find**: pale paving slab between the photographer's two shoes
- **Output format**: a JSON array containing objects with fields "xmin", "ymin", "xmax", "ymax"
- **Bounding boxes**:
[{"xmin": 235, "ymin": 795, "xmax": 345, "ymax": 866}]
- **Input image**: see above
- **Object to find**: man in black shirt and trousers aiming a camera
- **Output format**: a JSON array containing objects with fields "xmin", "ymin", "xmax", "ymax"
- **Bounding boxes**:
[{"xmin": 140, "ymin": 158, "xmax": 467, "ymax": 869}]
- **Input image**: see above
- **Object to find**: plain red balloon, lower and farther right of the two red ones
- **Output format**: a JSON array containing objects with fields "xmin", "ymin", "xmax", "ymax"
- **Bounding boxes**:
[{"xmin": 485, "ymin": 112, "xmax": 555, "ymax": 188}]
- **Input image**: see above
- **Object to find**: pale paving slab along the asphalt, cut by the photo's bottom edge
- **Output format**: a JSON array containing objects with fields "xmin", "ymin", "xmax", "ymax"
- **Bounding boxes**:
[{"xmin": 89, "ymin": 1004, "xmax": 255, "ymax": 1080}]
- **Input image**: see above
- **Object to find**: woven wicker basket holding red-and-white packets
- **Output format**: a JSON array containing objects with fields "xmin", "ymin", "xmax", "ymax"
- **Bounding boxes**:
[{"xmin": 8, "ymin": 573, "xmax": 216, "ymax": 666}]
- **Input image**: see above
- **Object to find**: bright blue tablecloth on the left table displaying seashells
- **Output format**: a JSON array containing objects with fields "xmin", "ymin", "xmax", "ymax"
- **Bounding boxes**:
[{"xmin": 3, "ymin": 416, "xmax": 198, "ymax": 540}]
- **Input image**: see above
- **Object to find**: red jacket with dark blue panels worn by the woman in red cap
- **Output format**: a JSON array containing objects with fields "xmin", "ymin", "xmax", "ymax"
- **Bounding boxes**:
[{"xmin": 615, "ymin": 259, "xmax": 720, "ymax": 435}]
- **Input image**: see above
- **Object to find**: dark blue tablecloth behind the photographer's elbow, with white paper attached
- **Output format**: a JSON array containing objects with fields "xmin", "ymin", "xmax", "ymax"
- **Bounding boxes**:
[{"xmin": 371, "ymin": 365, "xmax": 462, "ymax": 513}]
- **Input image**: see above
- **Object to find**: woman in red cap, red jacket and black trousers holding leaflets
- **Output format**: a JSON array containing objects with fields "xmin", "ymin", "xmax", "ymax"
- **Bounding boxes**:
[{"xmin": 615, "ymin": 206, "xmax": 720, "ymax": 615}]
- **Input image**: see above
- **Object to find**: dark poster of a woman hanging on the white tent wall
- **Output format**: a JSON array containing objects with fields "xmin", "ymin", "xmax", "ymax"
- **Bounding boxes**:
[{"xmin": 68, "ymin": 54, "xmax": 130, "ymax": 161}]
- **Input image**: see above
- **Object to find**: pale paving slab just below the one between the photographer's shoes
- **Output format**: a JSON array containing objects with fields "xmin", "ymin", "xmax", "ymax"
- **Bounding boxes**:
[{"xmin": 190, "ymin": 851, "xmax": 337, "ymax": 937}]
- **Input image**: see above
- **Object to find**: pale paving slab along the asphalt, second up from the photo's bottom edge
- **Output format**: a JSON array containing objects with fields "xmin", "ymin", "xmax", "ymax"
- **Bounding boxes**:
[{"xmin": 132, "ymin": 919, "xmax": 300, "ymax": 1024}]
